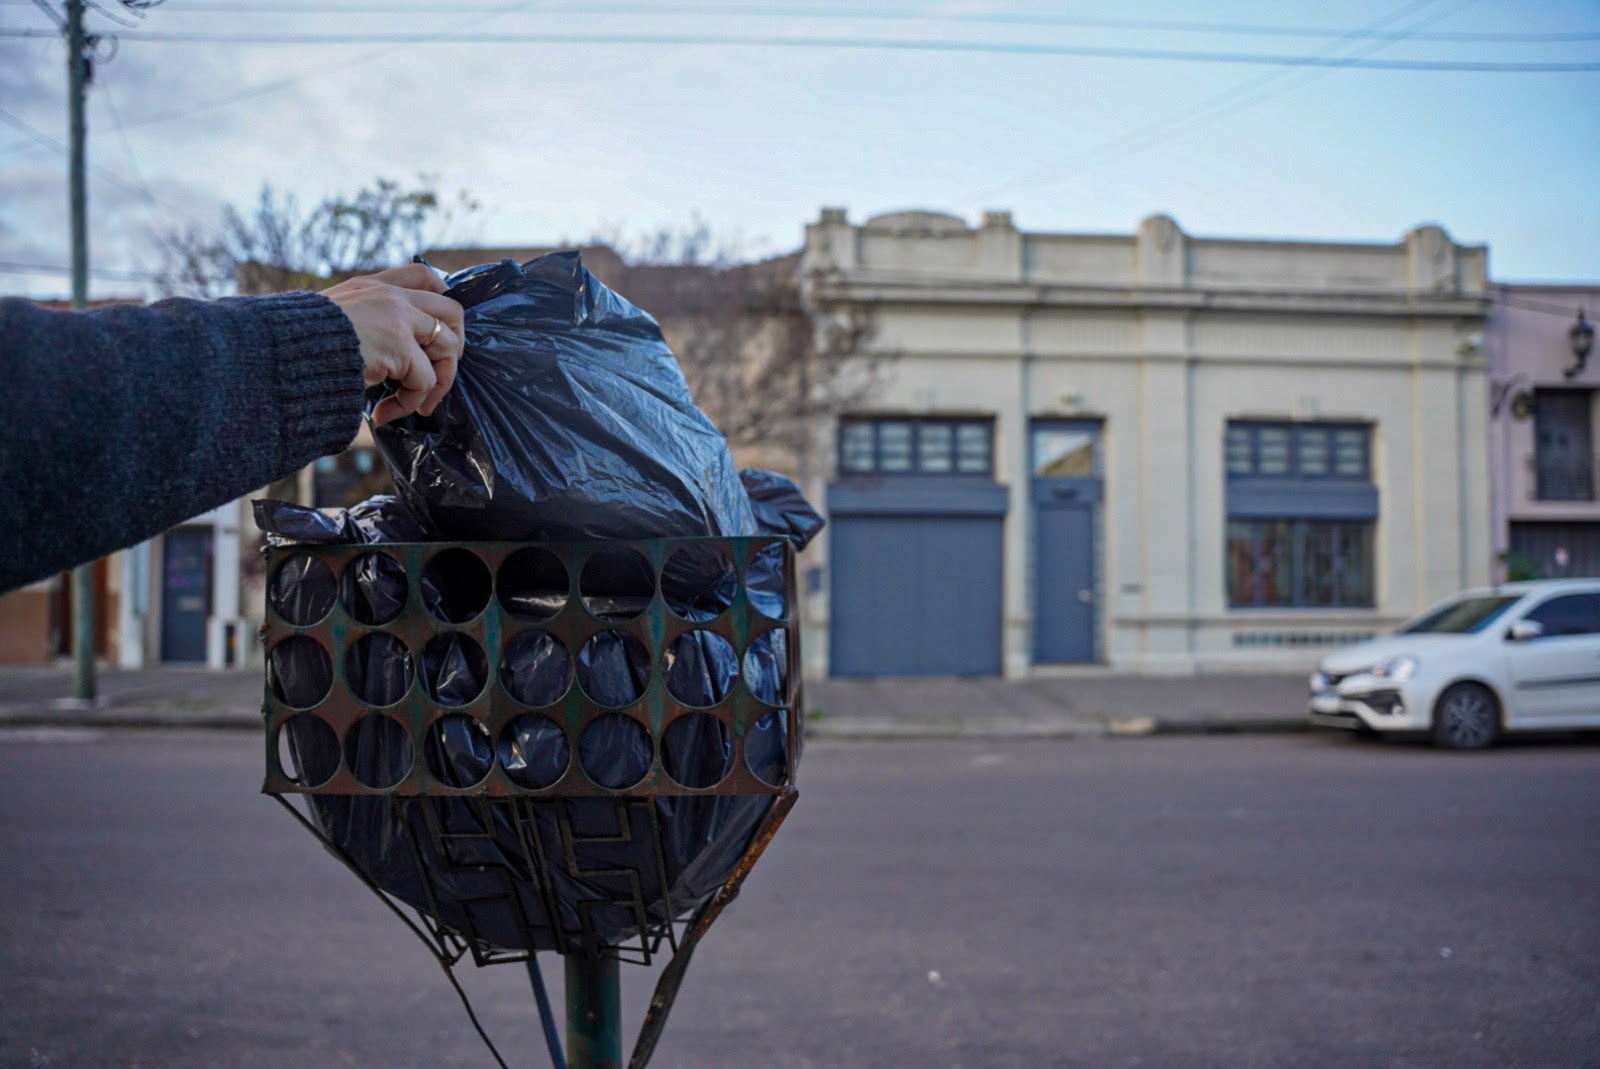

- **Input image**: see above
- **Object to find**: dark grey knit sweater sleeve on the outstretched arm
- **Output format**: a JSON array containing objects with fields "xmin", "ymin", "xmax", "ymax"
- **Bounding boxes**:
[{"xmin": 0, "ymin": 293, "xmax": 362, "ymax": 591}]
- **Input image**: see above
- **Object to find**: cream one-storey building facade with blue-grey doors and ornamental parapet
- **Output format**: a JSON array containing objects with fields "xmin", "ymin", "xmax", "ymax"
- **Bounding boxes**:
[{"xmin": 802, "ymin": 210, "xmax": 1493, "ymax": 677}]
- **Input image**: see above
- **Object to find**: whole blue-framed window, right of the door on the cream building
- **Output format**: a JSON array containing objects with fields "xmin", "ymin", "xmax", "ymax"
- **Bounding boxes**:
[{"xmin": 1222, "ymin": 419, "xmax": 1378, "ymax": 608}]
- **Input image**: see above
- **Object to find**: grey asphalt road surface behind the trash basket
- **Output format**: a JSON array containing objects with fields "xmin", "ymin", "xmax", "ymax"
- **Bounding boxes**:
[{"xmin": 0, "ymin": 731, "xmax": 1600, "ymax": 1069}]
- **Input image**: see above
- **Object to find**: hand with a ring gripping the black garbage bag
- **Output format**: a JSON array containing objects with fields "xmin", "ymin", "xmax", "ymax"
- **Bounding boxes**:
[{"xmin": 322, "ymin": 264, "xmax": 462, "ymax": 424}]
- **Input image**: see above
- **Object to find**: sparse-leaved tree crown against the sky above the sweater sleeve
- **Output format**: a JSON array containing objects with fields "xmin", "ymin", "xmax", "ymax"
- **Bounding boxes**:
[{"xmin": 155, "ymin": 178, "xmax": 477, "ymax": 298}]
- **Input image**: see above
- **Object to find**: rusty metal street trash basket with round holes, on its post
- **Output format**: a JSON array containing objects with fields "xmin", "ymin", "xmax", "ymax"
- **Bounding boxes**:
[{"xmin": 261, "ymin": 538, "xmax": 805, "ymax": 1067}]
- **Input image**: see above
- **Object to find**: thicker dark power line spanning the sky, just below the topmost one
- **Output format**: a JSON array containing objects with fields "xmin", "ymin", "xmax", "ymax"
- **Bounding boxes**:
[{"xmin": 0, "ymin": 30, "xmax": 1600, "ymax": 74}]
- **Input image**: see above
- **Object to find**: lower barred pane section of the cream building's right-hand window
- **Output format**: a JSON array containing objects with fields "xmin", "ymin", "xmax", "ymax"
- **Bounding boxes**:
[{"xmin": 1227, "ymin": 520, "xmax": 1373, "ymax": 608}]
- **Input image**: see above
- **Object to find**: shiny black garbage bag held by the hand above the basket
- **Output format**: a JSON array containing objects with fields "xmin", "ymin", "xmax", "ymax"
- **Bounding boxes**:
[{"xmin": 373, "ymin": 253, "xmax": 755, "ymax": 541}]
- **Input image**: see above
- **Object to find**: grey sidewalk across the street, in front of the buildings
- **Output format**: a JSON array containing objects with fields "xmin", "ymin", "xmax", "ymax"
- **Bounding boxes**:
[{"xmin": 0, "ymin": 666, "xmax": 1307, "ymax": 739}]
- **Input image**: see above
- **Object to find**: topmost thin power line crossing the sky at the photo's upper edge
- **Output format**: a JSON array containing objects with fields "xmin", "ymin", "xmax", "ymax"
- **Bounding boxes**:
[{"xmin": 0, "ymin": 0, "xmax": 1600, "ymax": 45}]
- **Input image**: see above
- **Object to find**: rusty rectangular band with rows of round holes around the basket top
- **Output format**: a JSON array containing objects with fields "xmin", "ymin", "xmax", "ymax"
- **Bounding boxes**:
[{"xmin": 262, "ymin": 538, "xmax": 803, "ymax": 797}]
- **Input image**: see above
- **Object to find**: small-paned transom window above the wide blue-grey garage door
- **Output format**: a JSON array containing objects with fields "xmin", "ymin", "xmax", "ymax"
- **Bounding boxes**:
[{"xmin": 838, "ymin": 416, "xmax": 994, "ymax": 475}]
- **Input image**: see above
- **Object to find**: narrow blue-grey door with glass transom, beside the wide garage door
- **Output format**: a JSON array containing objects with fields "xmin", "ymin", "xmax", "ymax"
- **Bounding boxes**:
[{"xmin": 1030, "ymin": 419, "xmax": 1101, "ymax": 664}]
